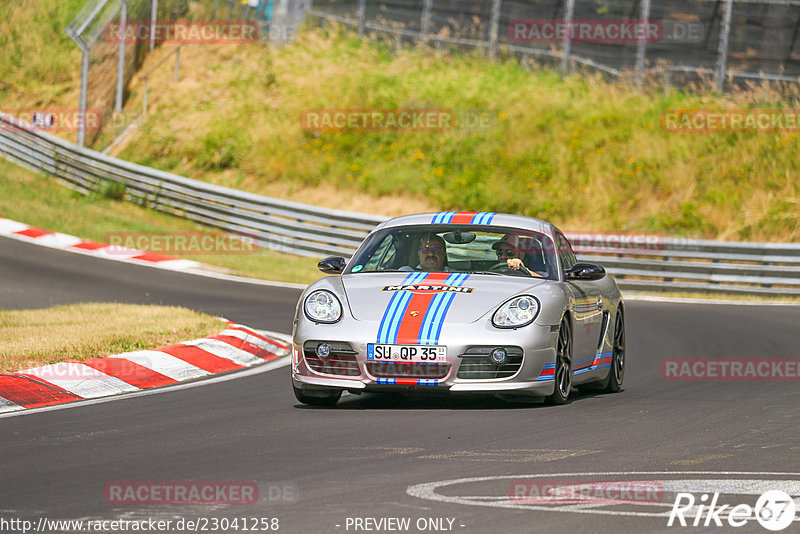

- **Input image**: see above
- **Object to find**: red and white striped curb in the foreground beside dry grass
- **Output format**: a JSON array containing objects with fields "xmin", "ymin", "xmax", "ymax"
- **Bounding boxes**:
[{"xmin": 0, "ymin": 322, "xmax": 291, "ymax": 413}]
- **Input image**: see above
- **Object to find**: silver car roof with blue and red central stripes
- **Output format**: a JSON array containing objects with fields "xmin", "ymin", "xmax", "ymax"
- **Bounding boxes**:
[{"xmin": 375, "ymin": 211, "xmax": 558, "ymax": 237}]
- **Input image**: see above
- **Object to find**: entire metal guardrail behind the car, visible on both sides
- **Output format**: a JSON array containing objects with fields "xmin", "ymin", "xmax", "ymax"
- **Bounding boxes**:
[{"xmin": 0, "ymin": 113, "xmax": 800, "ymax": 296}]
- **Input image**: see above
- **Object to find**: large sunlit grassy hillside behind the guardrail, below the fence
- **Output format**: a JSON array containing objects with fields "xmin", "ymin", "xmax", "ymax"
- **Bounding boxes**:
[{"xmin": 111, "ymin": 26, "xmax": 800, "ymax": 240}]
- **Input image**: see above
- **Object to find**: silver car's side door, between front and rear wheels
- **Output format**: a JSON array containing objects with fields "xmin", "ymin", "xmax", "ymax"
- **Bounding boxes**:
[{"xmin": 555, "ymin": 231, "xmax": 605, "ymax": 364}]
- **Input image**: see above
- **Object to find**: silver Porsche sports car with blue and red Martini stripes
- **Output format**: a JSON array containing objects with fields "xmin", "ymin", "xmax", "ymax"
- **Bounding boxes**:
[{"xmin": 292, "ymin": 212, "xmax": 625, "ymax": 405}]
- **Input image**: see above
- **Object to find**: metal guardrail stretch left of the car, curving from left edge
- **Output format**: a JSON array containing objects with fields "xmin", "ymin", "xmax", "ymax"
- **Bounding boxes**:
[{"xmin": 0, "ymin": 113, "xmax": 387, "ymax": 256}]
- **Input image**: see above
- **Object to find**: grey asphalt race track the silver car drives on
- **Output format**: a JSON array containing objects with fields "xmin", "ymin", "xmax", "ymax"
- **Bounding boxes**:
[{"xmin": 0, "ymin": 238, "xmax": 800, "ymax": 533}]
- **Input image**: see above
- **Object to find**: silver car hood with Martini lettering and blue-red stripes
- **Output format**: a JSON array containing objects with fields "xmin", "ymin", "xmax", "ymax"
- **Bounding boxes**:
[{"xmin": 342, "ymin": 272, "xmax": 546, "ymax": 323}]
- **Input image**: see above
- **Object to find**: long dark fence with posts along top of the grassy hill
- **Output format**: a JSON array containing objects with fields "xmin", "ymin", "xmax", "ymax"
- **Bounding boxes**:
[{"xmin": 310, "ymin": 0, "xmax": 800, "ymax": 89}]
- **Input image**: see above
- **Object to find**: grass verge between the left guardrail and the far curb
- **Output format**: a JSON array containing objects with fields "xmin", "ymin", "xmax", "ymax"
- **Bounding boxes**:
[{"xmin": 0, "ymin": 159, "xmax": 323, "ymax": 284}]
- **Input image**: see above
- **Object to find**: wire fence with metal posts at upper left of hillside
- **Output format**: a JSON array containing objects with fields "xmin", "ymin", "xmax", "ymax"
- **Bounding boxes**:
[{"xmin": 66, "ymin": 0, "xmax": 288, "ymax": 146}]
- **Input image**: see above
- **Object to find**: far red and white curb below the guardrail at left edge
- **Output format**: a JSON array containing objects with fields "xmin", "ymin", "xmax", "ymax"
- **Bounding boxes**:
[{"xmin": 0, "ymin": 217, "xmax": 204, "ymax": 271}]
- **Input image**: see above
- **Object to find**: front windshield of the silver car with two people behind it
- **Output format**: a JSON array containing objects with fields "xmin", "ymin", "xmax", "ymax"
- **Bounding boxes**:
[{"xmin": 345, "ymin": 224, "xmax": 558, "ymax": 280}]
